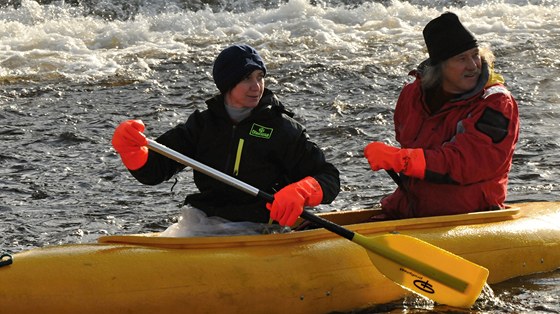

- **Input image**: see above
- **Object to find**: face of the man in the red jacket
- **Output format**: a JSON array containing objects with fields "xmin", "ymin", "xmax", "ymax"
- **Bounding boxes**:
[{"xmin": 442, "ymin": 48, "xmax": 482, "ymax": 94}]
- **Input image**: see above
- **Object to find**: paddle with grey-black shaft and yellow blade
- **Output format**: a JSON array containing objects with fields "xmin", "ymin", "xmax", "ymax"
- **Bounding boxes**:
[{"xmin": 148, "ymin": 139, "xmax": 488, "ymax": 308}]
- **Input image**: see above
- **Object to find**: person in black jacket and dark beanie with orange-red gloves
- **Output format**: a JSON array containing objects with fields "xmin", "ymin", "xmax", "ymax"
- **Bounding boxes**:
[{"xmin": 112, "ymin": 45, "xmax": 340, "ymax": 226}]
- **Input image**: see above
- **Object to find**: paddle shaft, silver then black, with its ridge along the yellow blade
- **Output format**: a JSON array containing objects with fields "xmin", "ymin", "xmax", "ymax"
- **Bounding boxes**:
[{"xmin": 148, "ymin": 139, "xmax": 468, "ymax": 291}]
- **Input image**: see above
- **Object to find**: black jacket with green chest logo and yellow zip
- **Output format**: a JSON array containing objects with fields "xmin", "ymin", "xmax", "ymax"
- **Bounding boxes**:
[{"xmin": 131, "ymin": 89, "xmax": 340, "ymax": 222}]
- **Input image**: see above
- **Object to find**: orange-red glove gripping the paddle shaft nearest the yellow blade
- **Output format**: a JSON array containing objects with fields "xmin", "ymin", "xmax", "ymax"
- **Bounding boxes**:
[{"xmin": 266, "ymin": 177, "xmax": 323, "ymax": 226}]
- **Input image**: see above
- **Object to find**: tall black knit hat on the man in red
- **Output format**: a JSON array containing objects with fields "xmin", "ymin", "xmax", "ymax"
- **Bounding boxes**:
[{"xmin": 422, "ymin": 12, "xmax": 478, "ymax": 65}]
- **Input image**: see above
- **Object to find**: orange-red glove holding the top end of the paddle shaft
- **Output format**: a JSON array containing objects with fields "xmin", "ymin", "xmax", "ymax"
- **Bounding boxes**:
[{"xmin": 112, "ymin": 120, "xmax": 148, "ymax": 170}]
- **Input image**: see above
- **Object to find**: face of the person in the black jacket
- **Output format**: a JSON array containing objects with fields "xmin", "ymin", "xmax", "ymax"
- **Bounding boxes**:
[{"xmin": 226, "ymin": 70, "xmax": 264, "ymax": 108}]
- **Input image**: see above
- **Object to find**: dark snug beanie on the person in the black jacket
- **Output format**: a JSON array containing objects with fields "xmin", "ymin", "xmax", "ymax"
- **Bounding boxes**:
[{"xmin": 212, "ymin": 45, "xmax": 266, "ymax": 94}]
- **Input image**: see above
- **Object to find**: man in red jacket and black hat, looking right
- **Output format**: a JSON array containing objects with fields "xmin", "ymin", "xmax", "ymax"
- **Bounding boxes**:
[{"xmin": 364, "ymin": 12, "xmax": 519, "ymax": 219}]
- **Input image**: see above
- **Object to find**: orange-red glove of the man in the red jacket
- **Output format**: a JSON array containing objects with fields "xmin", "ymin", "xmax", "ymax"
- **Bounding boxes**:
[{"xmin": 364, "ymin": 142, "xmax": 426, "ymax": 179}]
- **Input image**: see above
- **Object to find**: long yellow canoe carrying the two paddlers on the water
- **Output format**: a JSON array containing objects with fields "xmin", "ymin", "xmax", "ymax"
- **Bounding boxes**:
[{"xmin": 0, "ymin": 202, "xmax": 560, "ymax": 314}]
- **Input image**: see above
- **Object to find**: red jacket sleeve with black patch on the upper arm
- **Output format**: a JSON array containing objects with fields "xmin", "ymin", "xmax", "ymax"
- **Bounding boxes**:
[{"xmin": 424, "ymin": 85, "xmax": 519, "ymax": 185}]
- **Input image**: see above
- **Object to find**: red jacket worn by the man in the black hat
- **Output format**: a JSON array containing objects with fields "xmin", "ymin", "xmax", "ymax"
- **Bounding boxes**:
[{"xmin": 381, "ymin": 63, "xmax": 519, "ymax": 218}]
